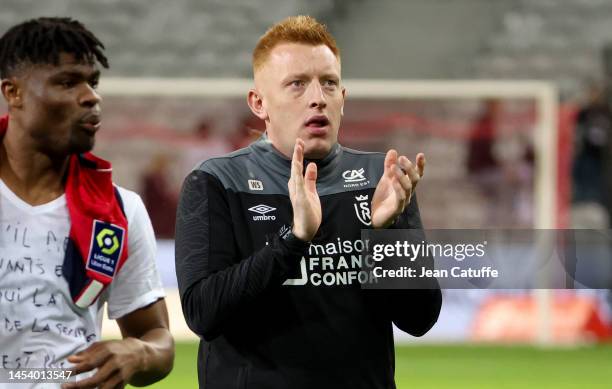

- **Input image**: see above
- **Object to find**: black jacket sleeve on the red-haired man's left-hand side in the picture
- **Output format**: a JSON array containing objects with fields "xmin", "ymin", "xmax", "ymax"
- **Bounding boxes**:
[{"xmin": 175, "ymin": 170, "xmax": 309, "ymax": 341}]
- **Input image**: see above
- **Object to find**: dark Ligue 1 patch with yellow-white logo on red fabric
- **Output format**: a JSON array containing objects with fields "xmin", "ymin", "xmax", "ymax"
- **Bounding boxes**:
[{"xmin": 87, "ymin": 220, "xmax": 125, "ymax": 278}]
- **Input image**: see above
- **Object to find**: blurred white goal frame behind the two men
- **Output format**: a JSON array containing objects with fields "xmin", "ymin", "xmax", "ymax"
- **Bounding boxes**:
[{"xmin": 100, "ymin": 77, "xmax": 559, "ymax": 344}]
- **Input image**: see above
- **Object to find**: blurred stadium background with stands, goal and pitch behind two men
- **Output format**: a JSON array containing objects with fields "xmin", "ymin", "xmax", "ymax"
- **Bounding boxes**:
[{"xmin": 0, "ymin": 0, "xmax": 612, "ymax": 389}]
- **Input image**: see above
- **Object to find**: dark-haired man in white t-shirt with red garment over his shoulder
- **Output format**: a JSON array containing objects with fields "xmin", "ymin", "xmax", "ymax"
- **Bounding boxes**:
[{"xmin": 0, "ymin": 18, "xmax": 174, "ymax": 388}]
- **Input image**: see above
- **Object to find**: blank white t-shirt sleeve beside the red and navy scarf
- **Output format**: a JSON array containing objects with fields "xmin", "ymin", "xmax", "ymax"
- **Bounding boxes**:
[{"xmin": 107, "ymin": 188, "xmax": 165, "ymax": 320}]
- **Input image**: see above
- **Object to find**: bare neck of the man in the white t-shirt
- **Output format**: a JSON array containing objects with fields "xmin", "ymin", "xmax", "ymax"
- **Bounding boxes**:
[{"xmin": 0, "ymin": 129, "xmax": 69, "ymax": 206}]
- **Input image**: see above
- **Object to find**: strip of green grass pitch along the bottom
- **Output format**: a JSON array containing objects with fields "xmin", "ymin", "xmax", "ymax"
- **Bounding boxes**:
[{"xmin": 139, "ymin": 343, "xmax": 612, "ymax": 389}]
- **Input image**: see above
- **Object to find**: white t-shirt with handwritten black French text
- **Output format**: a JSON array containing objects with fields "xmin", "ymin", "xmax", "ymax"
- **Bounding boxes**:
[{"xmin": 0, "ymin": 180, "xmax": 164, "ymax": 388}]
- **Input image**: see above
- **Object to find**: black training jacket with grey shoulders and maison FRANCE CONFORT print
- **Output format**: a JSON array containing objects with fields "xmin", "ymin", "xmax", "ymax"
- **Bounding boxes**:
[{"xmin": 176, "ymin": 136, "xmax": 442, "ymax": 389}]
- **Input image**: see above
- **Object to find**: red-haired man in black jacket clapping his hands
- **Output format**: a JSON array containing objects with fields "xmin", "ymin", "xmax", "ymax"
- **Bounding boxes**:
[{"xmin": 176, "ymin": 16, "xmax": 441, "ymax": 389}]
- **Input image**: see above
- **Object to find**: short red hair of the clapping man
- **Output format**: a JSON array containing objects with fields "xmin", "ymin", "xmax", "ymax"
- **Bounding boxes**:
[{"xmin": 253, "ymin": 15, "xmax": 340, "ymax": 72}]
